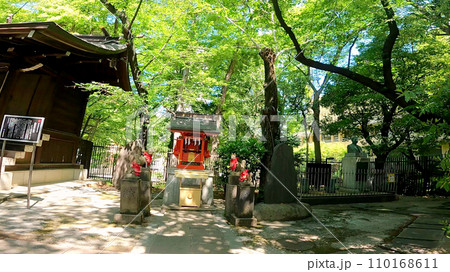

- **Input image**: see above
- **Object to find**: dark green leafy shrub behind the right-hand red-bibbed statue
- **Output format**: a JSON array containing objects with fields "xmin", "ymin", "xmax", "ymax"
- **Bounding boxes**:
[{"xmin": 215, "ymin": 138, "xmax": 266, "ymax": 184}]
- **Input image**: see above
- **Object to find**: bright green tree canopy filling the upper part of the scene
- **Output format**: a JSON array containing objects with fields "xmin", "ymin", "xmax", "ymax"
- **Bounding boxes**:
[{"xmin": 0, "ymin": 0, "xmax": 450, "ymax": 164}]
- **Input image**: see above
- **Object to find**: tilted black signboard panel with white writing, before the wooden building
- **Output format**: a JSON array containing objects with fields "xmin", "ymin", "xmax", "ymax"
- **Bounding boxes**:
[{"xmin": 0, "ymin": 114, "xmax": 45, "ymax": 144}]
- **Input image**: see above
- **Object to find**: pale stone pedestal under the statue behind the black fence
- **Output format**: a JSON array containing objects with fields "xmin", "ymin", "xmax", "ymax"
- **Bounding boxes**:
[{"xmin": 342, "ymin": 153, "xmax": 370, "ymax": 191}]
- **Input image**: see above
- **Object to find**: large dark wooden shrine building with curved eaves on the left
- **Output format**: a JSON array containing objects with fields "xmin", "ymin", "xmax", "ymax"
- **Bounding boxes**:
[{"xmin": 0, "ymin": 22, "xmax": 131, "ymax": 189}]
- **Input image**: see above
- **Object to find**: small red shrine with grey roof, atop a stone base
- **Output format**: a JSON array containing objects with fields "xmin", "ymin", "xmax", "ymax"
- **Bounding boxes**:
[{"xmin": 170, "ymin": 113, "xmax": 219, "ymax": 170}]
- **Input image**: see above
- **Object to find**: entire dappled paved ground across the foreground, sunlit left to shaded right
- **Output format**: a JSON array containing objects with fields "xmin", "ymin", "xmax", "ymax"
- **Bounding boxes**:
[{"xmin": 0, "ymin": 181, "xmax": 450, "ymax": 254}]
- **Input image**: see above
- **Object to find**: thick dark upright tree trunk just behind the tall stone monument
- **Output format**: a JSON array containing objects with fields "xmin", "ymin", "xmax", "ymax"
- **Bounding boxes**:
[{"xmin": 259, "ymin": 47, "xmax": 280, "ymax": 191}]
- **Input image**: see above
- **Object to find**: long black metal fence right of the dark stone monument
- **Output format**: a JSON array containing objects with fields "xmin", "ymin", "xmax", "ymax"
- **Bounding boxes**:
[{"xmin": 299, "ymin": 156, "xmax": 448, "ymax": 198}]
